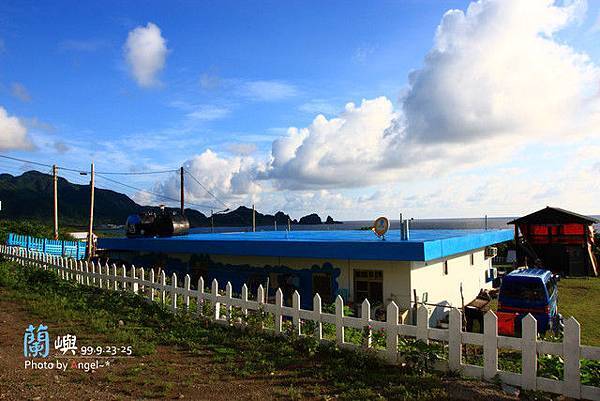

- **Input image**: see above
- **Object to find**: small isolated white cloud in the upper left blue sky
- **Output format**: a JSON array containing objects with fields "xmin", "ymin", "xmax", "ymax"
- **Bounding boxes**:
[{"xmin": 124, "ymin": 22, "xmax": 168, "ymax": 87}]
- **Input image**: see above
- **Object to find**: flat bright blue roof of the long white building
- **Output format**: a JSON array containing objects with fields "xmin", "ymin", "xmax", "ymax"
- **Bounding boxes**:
[{"xmin": 98, "ymin": 230, "xmax": 514, "ymax": 261}]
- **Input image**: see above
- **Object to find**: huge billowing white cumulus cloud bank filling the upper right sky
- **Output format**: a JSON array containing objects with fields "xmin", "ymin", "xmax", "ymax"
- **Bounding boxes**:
[{"xmin": 261, "ymin": 0, "xmax": 600, "ymax": 189}]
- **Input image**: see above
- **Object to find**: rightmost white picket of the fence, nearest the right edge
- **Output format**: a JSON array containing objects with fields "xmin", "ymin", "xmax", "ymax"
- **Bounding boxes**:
[{"xmin": 563, "ymin": 316, "xmax": 581, "ymax": 399}]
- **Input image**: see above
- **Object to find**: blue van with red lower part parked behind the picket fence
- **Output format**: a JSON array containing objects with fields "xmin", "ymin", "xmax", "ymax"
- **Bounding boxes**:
[{"xmin": 497, "ymin": 268, "xmax": 561, "ymax": 336}]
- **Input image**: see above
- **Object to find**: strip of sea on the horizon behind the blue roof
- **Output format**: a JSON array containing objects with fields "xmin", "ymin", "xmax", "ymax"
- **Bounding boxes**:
[{"xmin": 190, "ymin": 217, "xmax": 515, "ymax": 233}]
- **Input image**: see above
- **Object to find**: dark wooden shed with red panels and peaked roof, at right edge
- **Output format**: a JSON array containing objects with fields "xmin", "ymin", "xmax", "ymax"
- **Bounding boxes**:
[{"xmin": 508, "ymin": 206, "xmax": 598, "ymax": 276}]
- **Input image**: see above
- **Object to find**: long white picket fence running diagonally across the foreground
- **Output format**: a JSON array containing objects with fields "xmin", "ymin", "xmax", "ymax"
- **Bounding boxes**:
[{"xmin": 0, "ymin": 245, "xmax": 600, "ymax": 400}]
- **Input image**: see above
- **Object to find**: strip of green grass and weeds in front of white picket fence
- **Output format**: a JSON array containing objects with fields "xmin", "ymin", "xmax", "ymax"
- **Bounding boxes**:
[{"xmin": 0, "ymin": 262, "xmax": 457, "ymax": 400}]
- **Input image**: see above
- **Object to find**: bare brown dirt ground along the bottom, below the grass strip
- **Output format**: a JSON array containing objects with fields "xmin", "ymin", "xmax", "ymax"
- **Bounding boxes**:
[{"xmin": 0, "ymin": 289, "xmax": 515, "ymax": 401}]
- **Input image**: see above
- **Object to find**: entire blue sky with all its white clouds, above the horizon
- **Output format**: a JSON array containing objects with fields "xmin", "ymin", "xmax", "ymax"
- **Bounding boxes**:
[{"xmin": 0, "ymin": 0, "xmax": 600, "ymax": 219}]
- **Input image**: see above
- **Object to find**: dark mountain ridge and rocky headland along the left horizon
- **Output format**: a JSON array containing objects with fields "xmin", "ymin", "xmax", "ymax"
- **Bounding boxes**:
[{"xmin": 0, "ymin": 171, "xmax": 337, "ymax": 227}]
